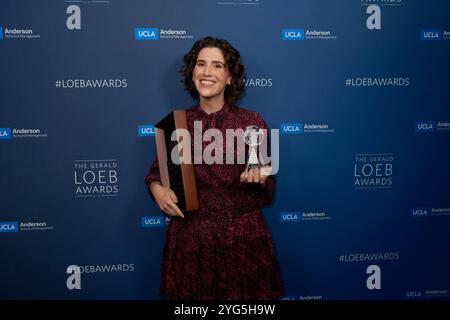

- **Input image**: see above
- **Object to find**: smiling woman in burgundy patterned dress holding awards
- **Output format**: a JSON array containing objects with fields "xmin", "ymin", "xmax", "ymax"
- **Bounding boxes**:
[{"xmin": 145, "ymin": 37, "xmax": 282, "ymax": 299}]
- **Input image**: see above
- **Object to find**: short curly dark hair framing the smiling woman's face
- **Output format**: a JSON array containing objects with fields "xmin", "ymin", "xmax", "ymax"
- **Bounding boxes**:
[{"xmin": 180, "ymin": 37, "xmax": 245, "ymax": 106}]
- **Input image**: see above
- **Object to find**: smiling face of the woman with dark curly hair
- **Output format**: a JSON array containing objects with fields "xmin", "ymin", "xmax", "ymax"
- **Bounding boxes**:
[{"xmin": 192, "ymin": 47, "xmax": 231, "ymax": 100}]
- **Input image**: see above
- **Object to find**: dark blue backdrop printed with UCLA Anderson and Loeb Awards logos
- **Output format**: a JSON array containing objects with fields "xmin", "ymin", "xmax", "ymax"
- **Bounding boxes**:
[{"xmin": 0, "ymin": 0, "xmax": 450, "ymax": 300}]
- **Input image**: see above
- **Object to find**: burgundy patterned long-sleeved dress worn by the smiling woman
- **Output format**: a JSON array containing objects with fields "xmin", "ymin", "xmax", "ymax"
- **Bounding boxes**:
[{"xmin": 145, "ymin": 104, "xmax": 282, "ymax": 299}]
